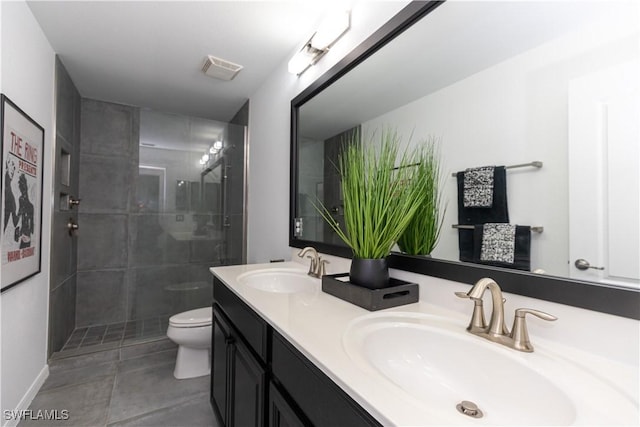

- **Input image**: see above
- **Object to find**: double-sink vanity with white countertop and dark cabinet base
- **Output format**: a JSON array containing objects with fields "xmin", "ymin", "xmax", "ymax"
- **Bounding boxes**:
[{"xmin": 211, "ymin": 262, "xmax": 639, "ymax": 426}]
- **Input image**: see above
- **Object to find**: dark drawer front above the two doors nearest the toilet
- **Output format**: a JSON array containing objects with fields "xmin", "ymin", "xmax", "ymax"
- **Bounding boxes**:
[{"xmin": 213, "ymin": 277, "xmax": 267, "ymax": 363}]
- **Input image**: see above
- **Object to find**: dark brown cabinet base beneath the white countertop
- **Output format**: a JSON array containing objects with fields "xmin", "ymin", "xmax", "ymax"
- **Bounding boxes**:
[{"xmin": 211, "ymin": 278, "xmax": 380, "ymax": 427}]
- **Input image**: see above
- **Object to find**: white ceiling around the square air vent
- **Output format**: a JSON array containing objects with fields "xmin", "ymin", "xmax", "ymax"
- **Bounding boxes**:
[{"xmin": 28, "ymin": 0, "xmax": 337, "ymax": 121}]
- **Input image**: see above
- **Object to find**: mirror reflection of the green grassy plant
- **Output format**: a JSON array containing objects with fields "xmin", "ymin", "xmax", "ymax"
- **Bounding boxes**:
[{"xmin": 398, "ymin": 138, "xmax": 446, "ymax": 255}]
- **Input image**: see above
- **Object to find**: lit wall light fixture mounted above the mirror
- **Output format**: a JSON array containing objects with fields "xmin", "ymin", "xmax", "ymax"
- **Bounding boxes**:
[{"xmin": 288, "ymin": 10, "xmax": 351, "ymax": 76}]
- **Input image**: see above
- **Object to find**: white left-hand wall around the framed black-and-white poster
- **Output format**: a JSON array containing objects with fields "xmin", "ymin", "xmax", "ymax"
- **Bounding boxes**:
[{"xmin": 0, "ymin": 1, "xmax": 55, "ymax": 425}]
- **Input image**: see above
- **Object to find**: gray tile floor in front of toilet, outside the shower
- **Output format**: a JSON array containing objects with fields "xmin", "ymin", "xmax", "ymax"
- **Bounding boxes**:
[{"xmin": 19, "ymin": 339, "xmax": 217, "ymax": 427}]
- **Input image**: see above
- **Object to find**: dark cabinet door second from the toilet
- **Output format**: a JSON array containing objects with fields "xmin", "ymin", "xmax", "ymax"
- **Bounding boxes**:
[{"xmin": 227, "ymin": 340, "xmax": 265, "ymax": 427}]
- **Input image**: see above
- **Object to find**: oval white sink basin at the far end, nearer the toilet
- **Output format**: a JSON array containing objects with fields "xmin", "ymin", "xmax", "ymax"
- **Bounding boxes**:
[{"xmin": 238, "ymin": 268, "xmax": 319, "ymax": 294}]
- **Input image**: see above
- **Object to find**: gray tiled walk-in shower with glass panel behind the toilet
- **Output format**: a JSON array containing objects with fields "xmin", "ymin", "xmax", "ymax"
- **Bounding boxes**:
[{"xmin": 49, "ymin": 58, "xmax": 248, "ymax": 354}]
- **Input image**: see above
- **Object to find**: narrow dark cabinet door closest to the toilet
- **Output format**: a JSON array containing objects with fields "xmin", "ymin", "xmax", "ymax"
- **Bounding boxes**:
[{"xmin": 211, "ymin": 306, "xmax": 233, "ymax": 425}]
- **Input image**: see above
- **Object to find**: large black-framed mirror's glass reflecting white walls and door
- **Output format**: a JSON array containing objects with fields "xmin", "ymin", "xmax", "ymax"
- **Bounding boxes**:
[{"xmin": 296, "ymin": 1, "xmax": 640, "ymax": 288}]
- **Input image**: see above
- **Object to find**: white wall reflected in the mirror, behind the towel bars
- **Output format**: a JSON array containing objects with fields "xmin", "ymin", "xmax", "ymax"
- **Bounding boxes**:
[{"xmin": 363, "ymin": 18, "xmax": 639, "ymax": 277}]
